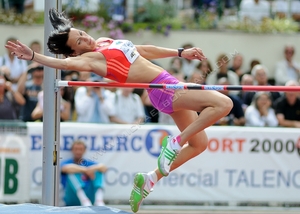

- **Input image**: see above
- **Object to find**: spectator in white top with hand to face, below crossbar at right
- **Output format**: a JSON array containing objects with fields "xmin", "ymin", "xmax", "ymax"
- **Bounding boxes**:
[{"xmin": 245, "ymin": 92, "xmax": 278, "ymax": 127}]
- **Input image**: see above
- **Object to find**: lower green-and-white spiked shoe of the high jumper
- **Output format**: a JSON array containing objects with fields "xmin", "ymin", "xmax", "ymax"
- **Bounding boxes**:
[{"xmin": 129, "ymin": 173, "xmax": 149, "ymax": 213}]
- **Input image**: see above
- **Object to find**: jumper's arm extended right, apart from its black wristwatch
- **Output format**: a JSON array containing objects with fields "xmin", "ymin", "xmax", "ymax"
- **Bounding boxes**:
[{"xmin": 136, "ymin": 45, "xmax": 206, "ymax": 60}]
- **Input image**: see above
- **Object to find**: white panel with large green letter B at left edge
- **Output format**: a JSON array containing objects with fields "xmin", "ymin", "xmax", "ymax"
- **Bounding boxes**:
[{"xmin": 0, "ymin": 133, "xmax": 30, "ymax": 202}]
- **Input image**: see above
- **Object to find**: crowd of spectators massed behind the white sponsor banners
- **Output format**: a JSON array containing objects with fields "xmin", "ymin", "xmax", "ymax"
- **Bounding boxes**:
[{"xmin": 0, "ymin": 38, "xmax": 300, "ymax": 127}]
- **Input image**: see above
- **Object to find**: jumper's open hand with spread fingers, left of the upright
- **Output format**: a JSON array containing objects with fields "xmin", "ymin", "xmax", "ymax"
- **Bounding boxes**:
[{"xmin": 5, "ymin": 41, "xmax": 33, "ymax": 60}]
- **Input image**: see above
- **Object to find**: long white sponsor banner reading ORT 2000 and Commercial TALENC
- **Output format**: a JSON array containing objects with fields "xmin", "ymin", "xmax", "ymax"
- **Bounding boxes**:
[{"xmin": 28, "ymin": 123, "xmax": 300, "ymax": 202}]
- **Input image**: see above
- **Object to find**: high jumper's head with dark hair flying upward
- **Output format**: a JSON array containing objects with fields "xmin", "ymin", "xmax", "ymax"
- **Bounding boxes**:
[{"xmin": 47, "ymin": 9, "xmax": 96, "ymax": 57}]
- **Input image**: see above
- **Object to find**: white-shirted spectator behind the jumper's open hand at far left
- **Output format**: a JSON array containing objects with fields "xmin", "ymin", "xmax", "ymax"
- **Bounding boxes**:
[{"xmin": 0, "ymin": 37, "xmax": 27, "ymax": 90}]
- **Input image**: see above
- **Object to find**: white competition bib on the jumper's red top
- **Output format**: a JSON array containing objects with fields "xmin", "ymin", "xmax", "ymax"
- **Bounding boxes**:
[{"xmin": 108, "ymin": 40, "xmax": 140, "ymax": 64}]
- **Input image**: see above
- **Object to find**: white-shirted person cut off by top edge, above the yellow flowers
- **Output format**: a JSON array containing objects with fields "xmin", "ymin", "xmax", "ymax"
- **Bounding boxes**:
[{"xmin": 240, "ymin": 0, "xmax": 270, "ymax": 22}]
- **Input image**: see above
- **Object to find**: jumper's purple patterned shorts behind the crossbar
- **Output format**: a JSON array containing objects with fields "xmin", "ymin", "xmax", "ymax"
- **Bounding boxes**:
[{"xmin": 147, "ymin": 71, "xmax": 179, "ymax": 114}]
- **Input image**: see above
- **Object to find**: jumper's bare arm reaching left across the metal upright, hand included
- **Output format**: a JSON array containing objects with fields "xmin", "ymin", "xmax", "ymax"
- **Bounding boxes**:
[{"xmin": 5, "ymin": 41, "xmax": 92, "ymax": 71}]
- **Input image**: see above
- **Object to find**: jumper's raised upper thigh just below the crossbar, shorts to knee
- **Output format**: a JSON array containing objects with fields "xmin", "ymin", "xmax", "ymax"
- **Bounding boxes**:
[{"xmin": 173, "ymin": 90, "xmax": 226, "ymax": 112}]
